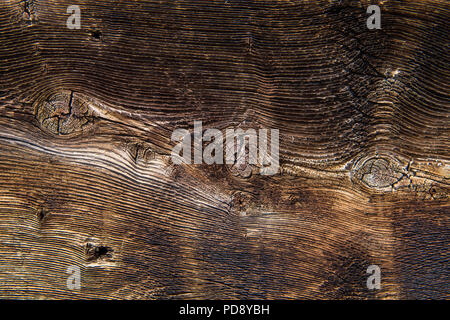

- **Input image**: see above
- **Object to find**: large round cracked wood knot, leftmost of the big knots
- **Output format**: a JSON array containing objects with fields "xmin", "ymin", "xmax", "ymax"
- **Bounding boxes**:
[{"xmin": 35, "ymin": 91, "xmax": 94, "ymax": 135}]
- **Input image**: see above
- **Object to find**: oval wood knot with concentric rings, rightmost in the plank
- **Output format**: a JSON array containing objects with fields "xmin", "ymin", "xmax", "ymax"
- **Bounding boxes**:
[{"xmin": 353, "ymin": 157, "xmax": 405, "ymax": 191}]
